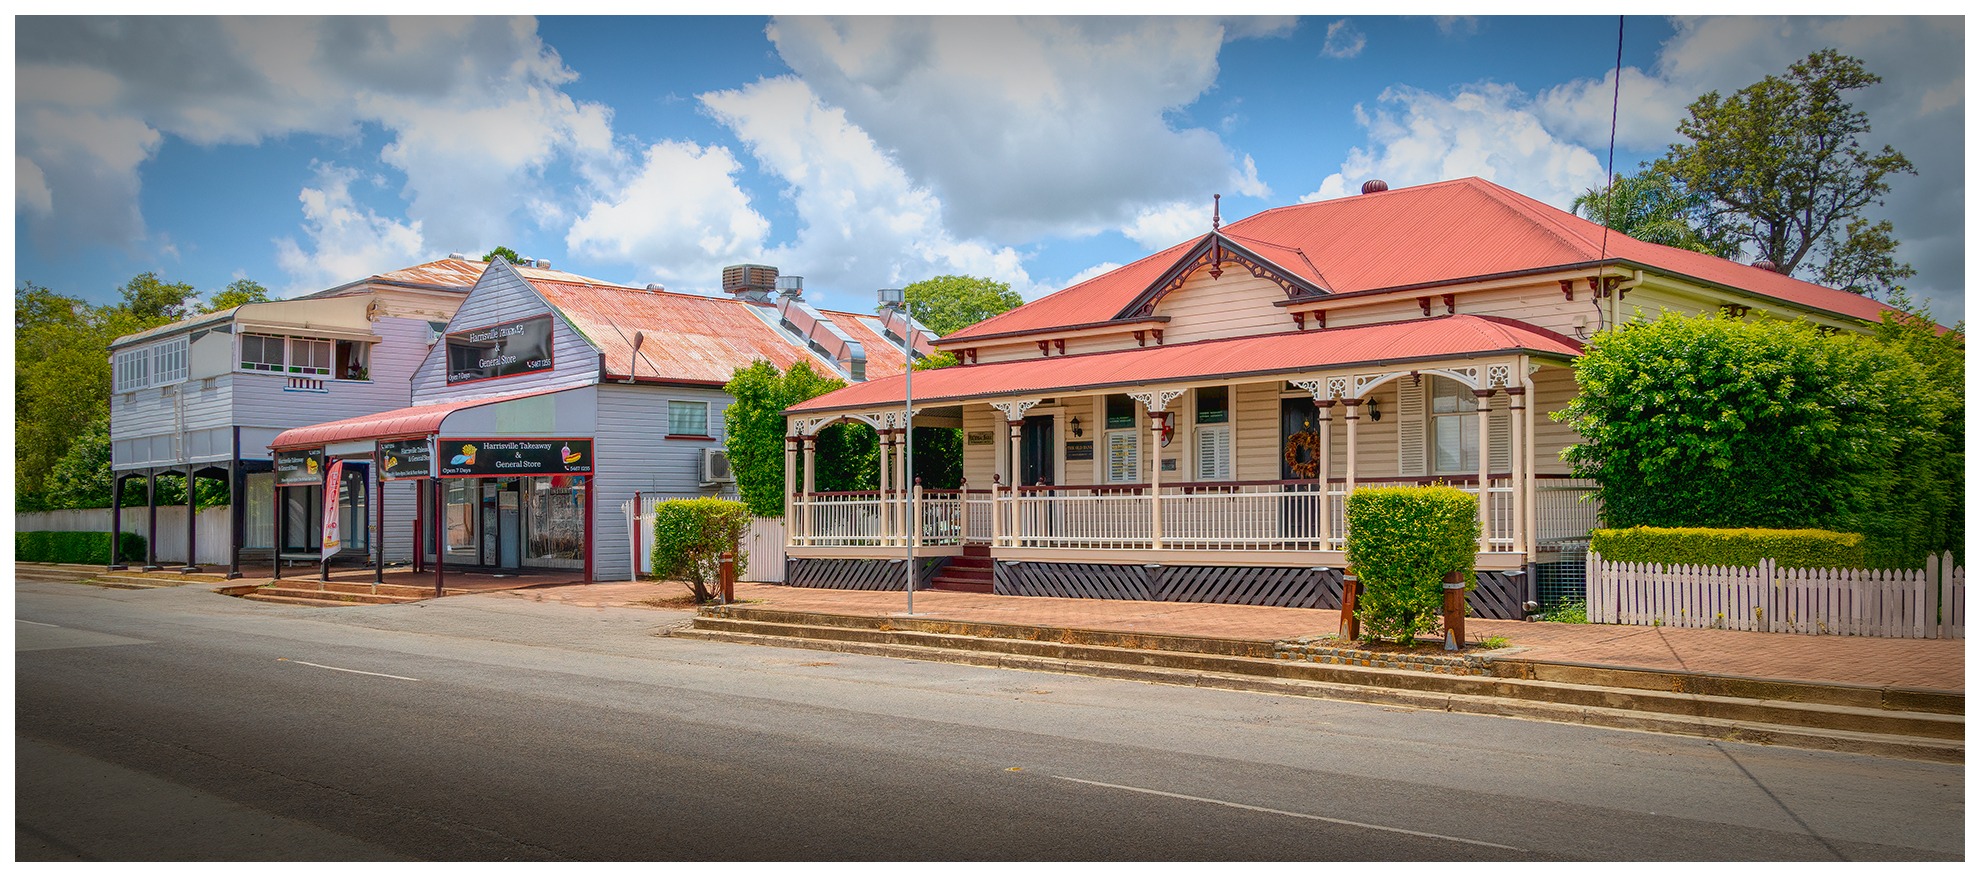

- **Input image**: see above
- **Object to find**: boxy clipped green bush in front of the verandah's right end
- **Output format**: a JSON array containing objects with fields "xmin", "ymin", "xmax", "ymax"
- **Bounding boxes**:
[{"xmin": 1346, "ymin": 487, "xmax": 1479, "ymax": 645}]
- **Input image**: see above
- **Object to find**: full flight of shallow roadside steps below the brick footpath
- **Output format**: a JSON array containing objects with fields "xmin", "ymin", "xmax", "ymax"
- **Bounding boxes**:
[{"xmin": 671, "ymin": 606, "xmax": 1966, "ymax": 762}]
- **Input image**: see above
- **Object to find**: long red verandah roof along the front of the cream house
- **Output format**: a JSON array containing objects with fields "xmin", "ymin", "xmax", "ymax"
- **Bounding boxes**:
[{"xmin": 790, "ymin": 315, "xmax": 1582, "ymax": 414}]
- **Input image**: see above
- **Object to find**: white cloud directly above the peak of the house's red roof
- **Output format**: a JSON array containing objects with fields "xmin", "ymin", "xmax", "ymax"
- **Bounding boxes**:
[{"xmin": 1301, "ymin": 83, "xmax": 1602, "ymax": 208}]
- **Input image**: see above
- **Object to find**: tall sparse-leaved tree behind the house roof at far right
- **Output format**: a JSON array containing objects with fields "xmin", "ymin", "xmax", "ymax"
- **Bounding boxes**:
[{"xmin": 1653, "ymin": 49, "xmax": 1917, "ymax": 295}]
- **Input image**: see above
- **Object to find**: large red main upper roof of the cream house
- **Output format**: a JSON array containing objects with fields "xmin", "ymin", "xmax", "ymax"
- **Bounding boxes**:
[{"xmin": 944, "ymin": 176, "xmax": 1916, "ymax": 341}]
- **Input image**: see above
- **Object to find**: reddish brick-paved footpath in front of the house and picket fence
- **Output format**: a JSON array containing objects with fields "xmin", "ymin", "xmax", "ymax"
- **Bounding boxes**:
[{"xmin": 505, "ymin": 582, "xmax": 1966, "ymax": 691}]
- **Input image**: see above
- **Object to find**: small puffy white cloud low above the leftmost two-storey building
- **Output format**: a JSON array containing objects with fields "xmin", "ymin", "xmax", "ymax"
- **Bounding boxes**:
[{"xmin": 275, "ymin": 162, "xmax": 426, "ymax": 295}]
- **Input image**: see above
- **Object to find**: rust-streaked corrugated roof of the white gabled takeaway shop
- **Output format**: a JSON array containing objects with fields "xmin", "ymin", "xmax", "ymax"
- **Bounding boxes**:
[{"xmin": 531, "ymin": 279, "xmax": 901, "ymax": 384}]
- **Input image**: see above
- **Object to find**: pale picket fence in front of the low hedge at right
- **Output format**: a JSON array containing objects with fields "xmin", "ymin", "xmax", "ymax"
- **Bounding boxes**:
[{"xmin": 1588, "ymin": 552, "xmax": 1966, "ymax": 639}]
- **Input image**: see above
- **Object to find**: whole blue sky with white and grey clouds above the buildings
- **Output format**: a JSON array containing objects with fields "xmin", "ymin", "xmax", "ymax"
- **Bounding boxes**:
[{"xmin": 14, "ymin": 16, "xmax": 1966, "ymax": 323}]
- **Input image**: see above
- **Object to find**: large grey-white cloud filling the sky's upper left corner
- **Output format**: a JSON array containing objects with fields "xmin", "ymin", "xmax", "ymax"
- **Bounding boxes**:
[{"xmin": 16, "ymin": 16, "xmax": 610, "ymax": 269}]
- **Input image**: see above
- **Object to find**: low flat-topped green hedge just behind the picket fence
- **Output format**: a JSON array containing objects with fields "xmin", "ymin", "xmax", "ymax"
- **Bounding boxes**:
[{"xmin": 1588, "ymin": 527, "xmax": 1865, "ymax": 568}]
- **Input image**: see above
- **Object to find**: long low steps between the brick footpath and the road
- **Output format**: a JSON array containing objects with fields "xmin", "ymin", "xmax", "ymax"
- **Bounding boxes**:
[{"xmin": 693, "ymin": 606, "xmax": 1966, "ymax": 764}]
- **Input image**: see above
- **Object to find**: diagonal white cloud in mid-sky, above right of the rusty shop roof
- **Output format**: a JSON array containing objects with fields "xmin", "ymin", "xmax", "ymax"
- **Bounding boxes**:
[{"xmin": 701, "ymin": 77, "xmax": 1032, "ymax": 307}]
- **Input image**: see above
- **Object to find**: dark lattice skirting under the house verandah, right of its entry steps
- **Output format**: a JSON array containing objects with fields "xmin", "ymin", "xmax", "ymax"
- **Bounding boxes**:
[{"xmin": 996, "ymin": 560, "xmax": 1527, "ymax": 618}]
